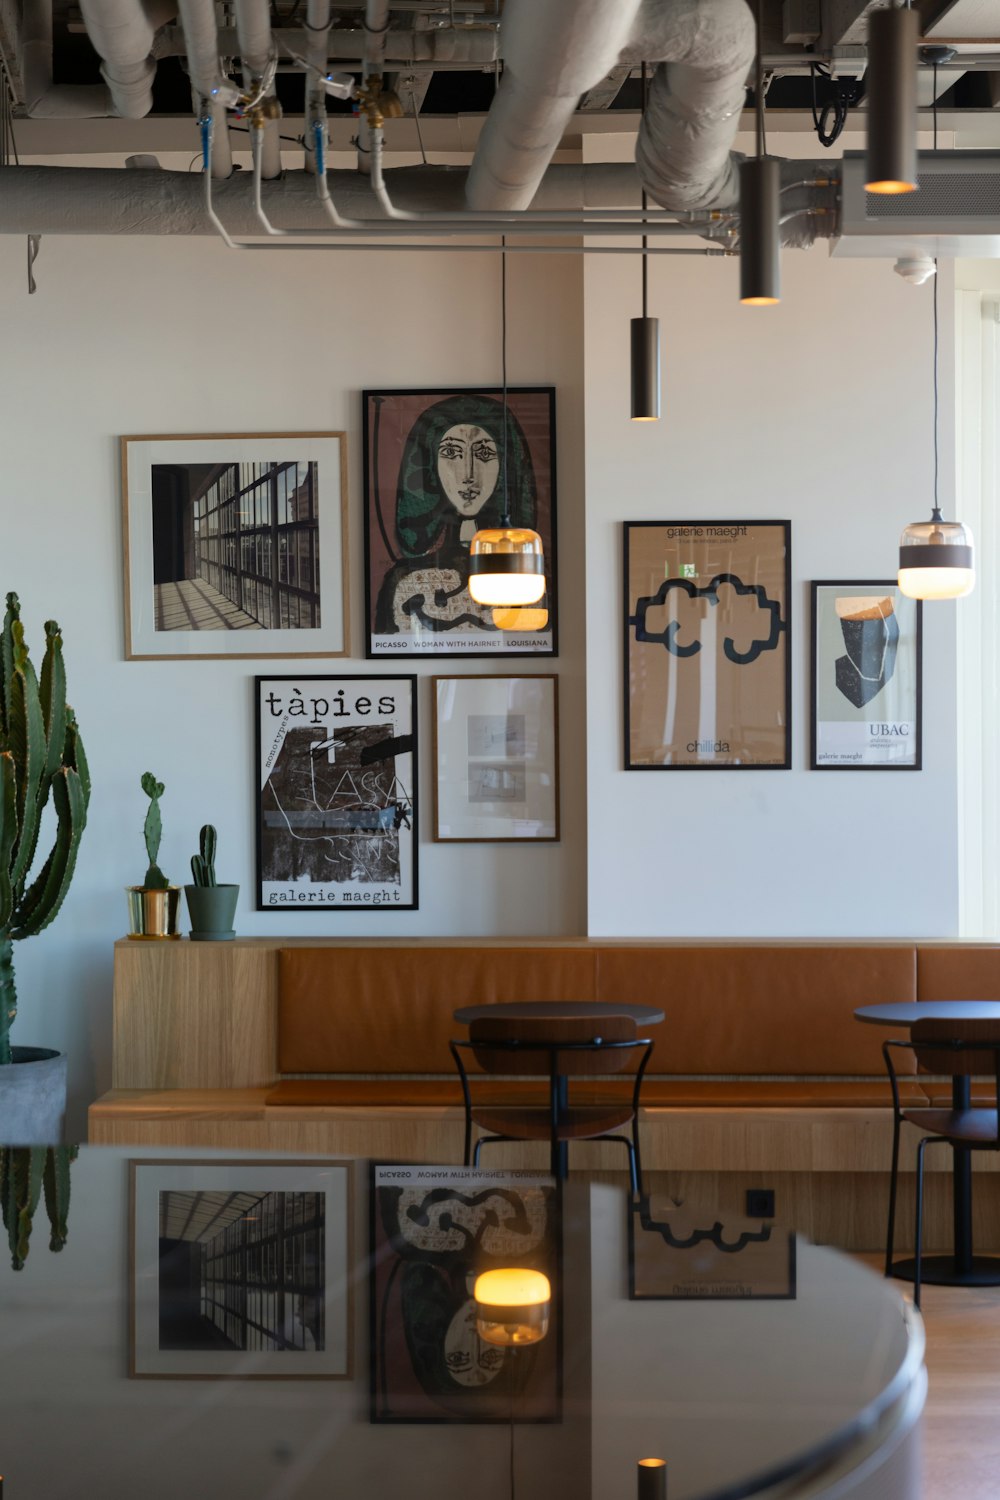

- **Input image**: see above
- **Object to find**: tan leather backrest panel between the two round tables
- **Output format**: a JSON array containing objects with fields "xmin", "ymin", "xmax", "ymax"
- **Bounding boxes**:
[{"xmin": 597, "ymin": 944, "xmax": 916, "ymax": 1077}]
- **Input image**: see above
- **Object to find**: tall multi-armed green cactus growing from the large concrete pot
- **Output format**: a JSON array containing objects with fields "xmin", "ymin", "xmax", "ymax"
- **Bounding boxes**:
[{"xmin": 0, "ymin": 594, "xmax": 90, "ymax": 1064}]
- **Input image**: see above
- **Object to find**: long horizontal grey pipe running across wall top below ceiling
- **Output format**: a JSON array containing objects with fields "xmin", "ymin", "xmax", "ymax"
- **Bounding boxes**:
[{"xmin": 0, "ymin": 161, "xmax": 840, "ymax": 237}]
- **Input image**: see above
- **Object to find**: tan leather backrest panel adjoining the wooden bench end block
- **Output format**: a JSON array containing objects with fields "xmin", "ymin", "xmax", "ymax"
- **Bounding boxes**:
[{"xmin": 277, "ymin": 944, "xmax": 599, "ymax": 1073}]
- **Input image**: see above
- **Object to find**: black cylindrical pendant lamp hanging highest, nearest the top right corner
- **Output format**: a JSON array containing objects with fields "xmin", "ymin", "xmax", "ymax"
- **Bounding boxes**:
[{"xmin": 865, "ymin": 11, "xmax": 921, "ymax": 194}]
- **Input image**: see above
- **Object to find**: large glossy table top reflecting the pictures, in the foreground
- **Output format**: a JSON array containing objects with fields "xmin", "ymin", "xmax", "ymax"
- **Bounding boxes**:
[{"xmin": 0, "ymin": 1148, "xmax": 922, "ymax": 1500}]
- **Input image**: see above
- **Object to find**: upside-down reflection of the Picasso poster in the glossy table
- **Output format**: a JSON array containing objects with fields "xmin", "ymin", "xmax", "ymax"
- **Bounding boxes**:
[{"xmin": 372, "ymin": 1166, "xmax": 559, "ymax": 1422}]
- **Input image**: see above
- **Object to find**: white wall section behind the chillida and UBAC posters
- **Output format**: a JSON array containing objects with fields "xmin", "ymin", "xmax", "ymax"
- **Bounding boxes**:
[{"xmin": 585, "ymin": 228, "xmax": 958, "ymax": 936}]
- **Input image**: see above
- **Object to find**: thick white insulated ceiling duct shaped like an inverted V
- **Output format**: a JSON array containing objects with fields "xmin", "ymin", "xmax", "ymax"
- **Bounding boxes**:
[{"xmin": 468, "ymin": 0, "xmax": 756, "ymax": 212}]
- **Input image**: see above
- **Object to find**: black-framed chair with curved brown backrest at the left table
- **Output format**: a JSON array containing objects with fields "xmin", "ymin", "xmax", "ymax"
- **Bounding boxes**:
[{"xmin": 450, "ymin": 1007, "xmax": 652, "ymax": 1193}]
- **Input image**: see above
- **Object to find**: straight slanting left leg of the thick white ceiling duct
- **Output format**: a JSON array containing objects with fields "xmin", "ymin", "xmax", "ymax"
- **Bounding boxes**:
[{"xmin": 466, "ymin": 0, "xmax": 639, "ymax": 210}]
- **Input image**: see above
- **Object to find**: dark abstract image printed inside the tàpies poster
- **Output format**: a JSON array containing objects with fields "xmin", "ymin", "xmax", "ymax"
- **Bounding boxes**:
[{"xmin": 261, "ymin": 725, "xmax": 412, "ymax": 885}]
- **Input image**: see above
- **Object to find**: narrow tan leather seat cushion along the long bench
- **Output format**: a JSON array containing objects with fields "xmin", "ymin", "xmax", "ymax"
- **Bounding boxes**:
[{"xmin": 264, "ymin": 1079, "xmax": 930, "ymax": 1110}]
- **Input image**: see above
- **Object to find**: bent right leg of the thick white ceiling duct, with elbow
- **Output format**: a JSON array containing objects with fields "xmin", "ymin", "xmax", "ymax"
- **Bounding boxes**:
[{"xmin": 624, "ymin": 0, "xmax": 756, "ymax": 212}]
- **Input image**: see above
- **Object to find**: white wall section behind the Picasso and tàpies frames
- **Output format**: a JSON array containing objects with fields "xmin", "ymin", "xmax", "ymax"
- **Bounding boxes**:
[{"xmin": 0, "ymin": 228, "xmax": 586, "ymax": 1131}]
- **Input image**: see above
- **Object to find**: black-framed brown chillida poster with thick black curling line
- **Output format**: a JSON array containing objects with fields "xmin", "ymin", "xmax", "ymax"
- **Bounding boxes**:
[{"xmin": 625, "ymin": 521, "xmax": 792, "ymax": 771}]
